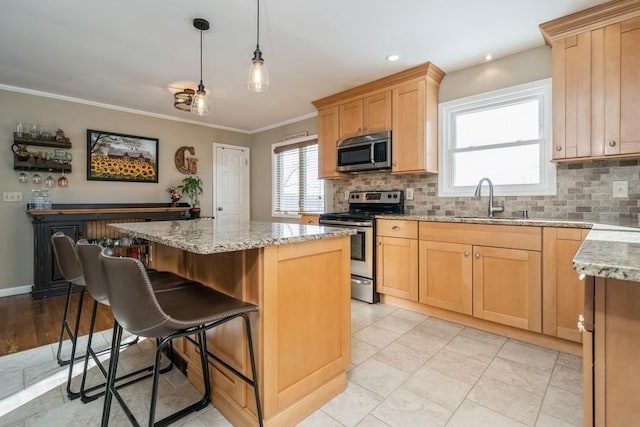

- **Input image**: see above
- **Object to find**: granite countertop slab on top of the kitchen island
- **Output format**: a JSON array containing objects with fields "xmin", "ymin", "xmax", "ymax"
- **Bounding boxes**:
[{"xmin": 107, "ymin": 219, "xmax": 356, "ymax": 255}]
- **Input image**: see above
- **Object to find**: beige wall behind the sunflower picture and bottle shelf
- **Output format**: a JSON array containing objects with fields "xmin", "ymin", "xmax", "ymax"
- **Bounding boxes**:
[{"xmin": 0, "ymin": 90, "xmax": 251, "ymax": 289}]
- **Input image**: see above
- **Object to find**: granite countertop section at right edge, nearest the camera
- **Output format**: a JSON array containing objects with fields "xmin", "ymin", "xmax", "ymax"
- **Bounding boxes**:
[{"xmin": 573, "ymin": 224, "xmax": 640, "ymax": 281}]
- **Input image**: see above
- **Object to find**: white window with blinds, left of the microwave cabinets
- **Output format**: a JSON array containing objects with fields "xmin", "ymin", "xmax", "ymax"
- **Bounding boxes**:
[{"xmin": 273, "ymin": 139, "xmax": 324, "ymax": 215}]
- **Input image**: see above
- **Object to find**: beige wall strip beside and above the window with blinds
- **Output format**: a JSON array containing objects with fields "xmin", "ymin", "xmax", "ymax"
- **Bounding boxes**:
[{"xmin": 251, "ymin": 117, "xmax": 316, "ymax": 221}]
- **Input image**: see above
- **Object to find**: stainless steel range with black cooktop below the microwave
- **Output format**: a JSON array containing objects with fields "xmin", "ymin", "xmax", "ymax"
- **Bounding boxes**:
[{"xmin": 320, "ymin": 190, "xmax": 404, "ymax": 304}]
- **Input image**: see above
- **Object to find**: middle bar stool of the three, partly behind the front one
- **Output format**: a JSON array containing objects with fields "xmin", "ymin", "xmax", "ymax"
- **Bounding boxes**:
[{"xmin": 75, "ymin": 239, "xmax": 193, "ymax": 403}]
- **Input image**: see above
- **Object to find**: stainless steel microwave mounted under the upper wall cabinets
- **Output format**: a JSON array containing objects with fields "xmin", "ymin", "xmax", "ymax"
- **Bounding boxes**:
[{"xmin": 337, "ymin": 131, "xmax": 391, "ymax": 172}]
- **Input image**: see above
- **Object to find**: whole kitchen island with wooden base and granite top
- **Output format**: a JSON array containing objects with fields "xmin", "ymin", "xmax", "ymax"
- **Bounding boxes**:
[{"xmin": 108, "ymin": 219, "xmax": 355, "ymax": 426}]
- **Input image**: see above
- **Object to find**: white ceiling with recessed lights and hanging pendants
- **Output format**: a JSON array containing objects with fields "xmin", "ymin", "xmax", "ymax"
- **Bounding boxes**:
[{"xmin": 0, "ymin": 0, "xmax": 603, "ymax": 132}]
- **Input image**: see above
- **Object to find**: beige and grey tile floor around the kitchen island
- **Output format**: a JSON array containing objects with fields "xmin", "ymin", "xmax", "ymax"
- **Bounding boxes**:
[{"xmin": 0, "ymin": 301, "xmax": 582, "ymax": 427}]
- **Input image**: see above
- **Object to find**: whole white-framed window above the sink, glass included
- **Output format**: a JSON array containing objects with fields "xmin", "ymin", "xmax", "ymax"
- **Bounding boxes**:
[{"xmin": 438, "ymin": 79, "xmax": 556, "ymax": 196}]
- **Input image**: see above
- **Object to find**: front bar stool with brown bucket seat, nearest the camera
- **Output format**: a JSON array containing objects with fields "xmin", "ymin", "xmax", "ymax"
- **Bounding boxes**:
[{"xmin": 100, "ymin": 251, "xmax": 262, "ymax": 426}]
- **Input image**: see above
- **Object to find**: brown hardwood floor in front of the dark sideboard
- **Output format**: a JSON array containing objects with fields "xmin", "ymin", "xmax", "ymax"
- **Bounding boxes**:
[{"xmin": 0, "ymin": 292, "xmax": 113, "ymax": 356}]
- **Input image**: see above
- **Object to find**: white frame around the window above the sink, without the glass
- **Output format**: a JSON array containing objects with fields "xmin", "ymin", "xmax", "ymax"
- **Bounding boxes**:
[{"xmin": 438, "ymin": 78, "xmax": 557, "ymax": 197}]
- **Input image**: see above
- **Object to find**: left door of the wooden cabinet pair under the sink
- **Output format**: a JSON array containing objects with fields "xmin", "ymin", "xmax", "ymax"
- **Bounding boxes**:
[{"xmin": 418, "ymin": 240, "xmax": 473, "ymax": 315}]
